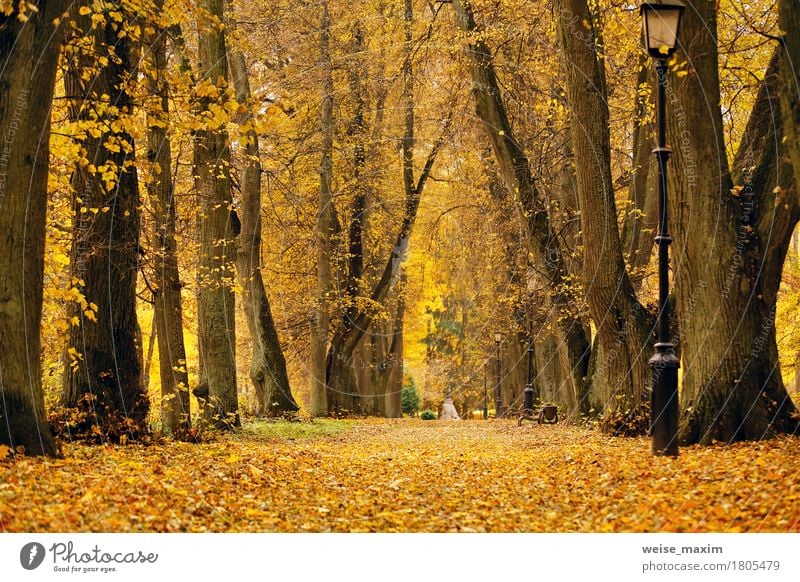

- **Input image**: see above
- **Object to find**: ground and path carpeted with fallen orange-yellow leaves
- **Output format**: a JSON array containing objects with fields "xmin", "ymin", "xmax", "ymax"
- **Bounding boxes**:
[{"xmin": 0, "ymin": 420, "xmax": 800, "ymax": 532}]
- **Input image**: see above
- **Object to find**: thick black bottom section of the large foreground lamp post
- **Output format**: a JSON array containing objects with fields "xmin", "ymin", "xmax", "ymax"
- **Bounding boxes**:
[{"xmin": 650, "ymin": 342, "xmax": 680, "ymax": 457}]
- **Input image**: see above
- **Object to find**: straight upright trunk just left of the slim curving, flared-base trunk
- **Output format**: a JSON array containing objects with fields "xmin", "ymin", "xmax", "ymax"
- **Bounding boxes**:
[{"xmin": 194, "ymin": 0, "xmax": 240, "ymax": 428}]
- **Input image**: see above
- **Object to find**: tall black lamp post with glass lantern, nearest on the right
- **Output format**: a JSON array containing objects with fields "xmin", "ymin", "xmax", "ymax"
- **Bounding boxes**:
[{"xmin": 640, "ymin": 0, "xmax": 685, "ymax": 456}]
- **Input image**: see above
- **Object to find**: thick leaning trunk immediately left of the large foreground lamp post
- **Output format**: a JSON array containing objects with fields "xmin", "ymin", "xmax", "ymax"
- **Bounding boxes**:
[{"xmin": 554, "ymin": 0, "xmax": 653, "ymax": 434}]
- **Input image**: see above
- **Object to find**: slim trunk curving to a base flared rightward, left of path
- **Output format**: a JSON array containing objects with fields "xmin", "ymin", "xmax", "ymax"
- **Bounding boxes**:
[{"xmin": 228, "ymin": 17, "xmax": 299, "ymax": 416}]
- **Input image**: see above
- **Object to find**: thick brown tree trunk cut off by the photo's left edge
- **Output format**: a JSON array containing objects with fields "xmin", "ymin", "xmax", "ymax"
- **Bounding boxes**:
[{"xmin": 0, "ymin": 0, "xmax": 67, "ymax": 456}]
